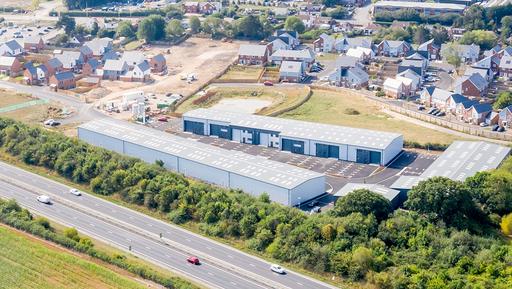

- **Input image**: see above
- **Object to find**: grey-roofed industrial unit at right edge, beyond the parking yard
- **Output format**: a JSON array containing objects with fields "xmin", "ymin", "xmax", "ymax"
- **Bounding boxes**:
[{"xmin": 391, "ymin": 141, "xmax": 510, "ymax": 191}]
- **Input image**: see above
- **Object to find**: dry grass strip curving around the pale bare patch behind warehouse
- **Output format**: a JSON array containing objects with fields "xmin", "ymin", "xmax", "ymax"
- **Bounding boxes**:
[{"xmin": 176, "ymin": 86, "xmax": 308, "ymax": 115}]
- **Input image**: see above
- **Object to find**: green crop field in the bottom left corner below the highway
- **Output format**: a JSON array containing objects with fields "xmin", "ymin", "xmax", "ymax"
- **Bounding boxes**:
[{"xmin": 0, "ymin": 226, "xmax": 146, "ymax": 289}]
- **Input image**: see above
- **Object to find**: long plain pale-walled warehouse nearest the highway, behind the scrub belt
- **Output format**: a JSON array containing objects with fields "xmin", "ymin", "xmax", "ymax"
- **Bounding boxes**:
[{"xmin": 78, "ymin": 119, "xmax": 325, "ymax": 206}]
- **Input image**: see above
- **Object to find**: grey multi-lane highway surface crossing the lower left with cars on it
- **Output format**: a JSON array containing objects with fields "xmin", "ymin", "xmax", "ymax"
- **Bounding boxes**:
[{"xmin": 0, "ymin": 162, "xmax": 334, "ymax": 289}]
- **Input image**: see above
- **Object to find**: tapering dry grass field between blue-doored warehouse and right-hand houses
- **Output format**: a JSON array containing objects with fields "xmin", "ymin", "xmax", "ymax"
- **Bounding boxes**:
[{"xmin": 280, "ymin": 90, "xmax": 460, "ymax": 144}]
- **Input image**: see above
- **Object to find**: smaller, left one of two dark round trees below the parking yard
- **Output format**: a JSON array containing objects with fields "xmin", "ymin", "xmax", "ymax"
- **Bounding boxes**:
[{"xmin": 332, "ymin": 189, "xmax": 391, "ymax": 220}]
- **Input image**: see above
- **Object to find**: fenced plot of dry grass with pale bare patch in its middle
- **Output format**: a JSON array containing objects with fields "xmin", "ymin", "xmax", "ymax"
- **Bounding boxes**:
[{"xmin": 176, "ymin": 85, "xmax": 308, "ymax": 115}]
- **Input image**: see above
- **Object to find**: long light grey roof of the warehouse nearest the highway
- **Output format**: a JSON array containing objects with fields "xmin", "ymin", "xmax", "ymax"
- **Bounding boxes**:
[{"xmin": 79, "ymin": 119, "xmax": 324, "ymax": 189}]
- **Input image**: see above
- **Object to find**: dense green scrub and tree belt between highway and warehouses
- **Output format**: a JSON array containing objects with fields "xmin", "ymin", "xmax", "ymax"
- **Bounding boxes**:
[{"xmin": 0, "ymin": 119, "xmax": 512, "ymax": 288}]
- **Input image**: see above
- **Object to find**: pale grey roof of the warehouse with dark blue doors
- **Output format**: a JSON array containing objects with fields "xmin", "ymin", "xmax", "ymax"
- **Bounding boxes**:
[{"xmin": 183, "ymin": 108, "xmax": 402, "ymax": 150}]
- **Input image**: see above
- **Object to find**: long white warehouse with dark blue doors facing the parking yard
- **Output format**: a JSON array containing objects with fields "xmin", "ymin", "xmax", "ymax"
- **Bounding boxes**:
[{"xmin": 183, "ymin": 109, "xmax": 403, "ymax": 165}]
